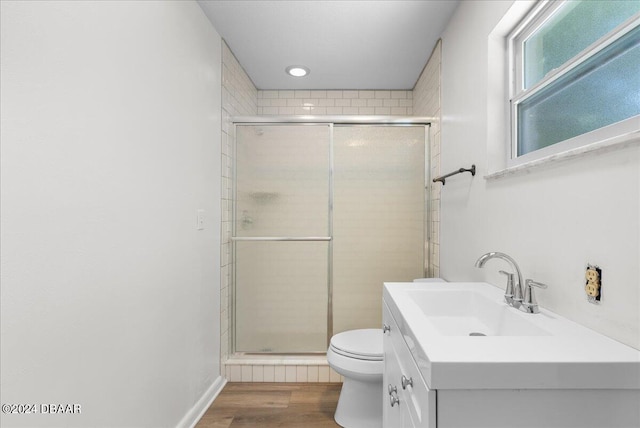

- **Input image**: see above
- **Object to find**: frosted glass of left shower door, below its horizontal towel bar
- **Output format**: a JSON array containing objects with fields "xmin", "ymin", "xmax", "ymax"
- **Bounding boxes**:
[{"xmin": 235, "ymin": 241, "xmax": 329, "ymax": 353}]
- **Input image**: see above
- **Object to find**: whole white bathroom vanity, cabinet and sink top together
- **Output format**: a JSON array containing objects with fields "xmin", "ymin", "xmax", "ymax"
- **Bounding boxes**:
[{"xmin": 383, "ymin": 283, "xmax": 640, "ymax": 428}]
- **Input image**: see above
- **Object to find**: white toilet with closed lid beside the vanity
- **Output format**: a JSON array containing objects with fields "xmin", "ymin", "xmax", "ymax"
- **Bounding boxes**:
[{"xmin": 327, "ymin": 328, "xmax": 384, "ymax": 428}]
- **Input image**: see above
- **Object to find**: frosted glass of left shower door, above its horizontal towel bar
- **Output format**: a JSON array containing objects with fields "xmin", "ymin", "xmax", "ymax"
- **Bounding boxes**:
[{"xmin": 236, "ymin": 125, "xmax": 330, "ymax": 237}]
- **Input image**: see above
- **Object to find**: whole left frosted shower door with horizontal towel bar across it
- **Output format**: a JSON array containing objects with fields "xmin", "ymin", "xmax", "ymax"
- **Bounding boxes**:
[{"xmin": 234, "ymin": 124, "xmax": 330, "ymax": 353}]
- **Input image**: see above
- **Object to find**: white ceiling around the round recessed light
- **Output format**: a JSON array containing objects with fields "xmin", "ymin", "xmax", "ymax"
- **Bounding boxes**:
[{"xmin": 198, "ymin": 0, "xmax": 458, "ymax": 90}]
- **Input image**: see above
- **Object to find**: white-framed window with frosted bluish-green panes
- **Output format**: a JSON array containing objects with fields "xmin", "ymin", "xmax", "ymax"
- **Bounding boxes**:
[{"xmin": 508, "ymin": 0, "xmax": 640, "ymax": 165}]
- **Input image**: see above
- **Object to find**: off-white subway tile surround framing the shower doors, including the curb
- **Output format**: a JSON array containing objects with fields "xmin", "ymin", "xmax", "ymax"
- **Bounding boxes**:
[{"xmin": 220, "ymin": 41, "xmax": 441, "ymax": 382}]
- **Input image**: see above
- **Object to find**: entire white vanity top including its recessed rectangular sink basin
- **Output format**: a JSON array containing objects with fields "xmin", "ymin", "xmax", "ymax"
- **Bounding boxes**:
[{"xmin": 383, "ymin": 282, "xmax": 640, "ymax": 389}]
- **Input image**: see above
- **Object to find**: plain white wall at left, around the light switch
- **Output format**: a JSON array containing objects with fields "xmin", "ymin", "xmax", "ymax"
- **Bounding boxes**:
[{"xmin": 0, "ymin": 1, "xmax": 222, "ymax": 427}]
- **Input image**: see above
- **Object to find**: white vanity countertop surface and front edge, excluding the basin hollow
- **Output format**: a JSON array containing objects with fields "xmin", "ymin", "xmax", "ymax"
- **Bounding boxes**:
[{"xmin": 383, "ymin": 283, "xmax": 640, "ymax": 389}]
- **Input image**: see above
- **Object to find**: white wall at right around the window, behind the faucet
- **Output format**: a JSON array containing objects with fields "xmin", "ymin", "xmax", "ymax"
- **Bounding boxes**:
[{"xmin": 440, "ymin": 1, "xmax": 640, "ymax": 348}]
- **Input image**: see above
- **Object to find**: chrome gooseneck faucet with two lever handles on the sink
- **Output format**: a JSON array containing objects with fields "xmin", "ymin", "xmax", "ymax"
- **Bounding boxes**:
[{"xmin": 476, "ymin": 252, "xmax": 547, "ymax": 314}]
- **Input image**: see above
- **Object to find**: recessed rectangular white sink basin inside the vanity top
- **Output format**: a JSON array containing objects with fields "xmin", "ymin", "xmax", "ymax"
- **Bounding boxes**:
[{"xmin": 407, "ymin": 289, "xmax": 550, "ymax": 337}]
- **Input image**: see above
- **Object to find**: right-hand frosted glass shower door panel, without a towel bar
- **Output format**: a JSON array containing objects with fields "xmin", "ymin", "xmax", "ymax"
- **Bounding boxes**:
[{"xmin": 333, "ymin": 126, "xmax": 425, "ymax": 334}]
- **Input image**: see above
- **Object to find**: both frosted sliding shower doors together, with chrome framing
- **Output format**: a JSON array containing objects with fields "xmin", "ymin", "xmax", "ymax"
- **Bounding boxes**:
[{"xmin": 232, "ymin": 118, "xmax": 429, "ymax": 354}]
